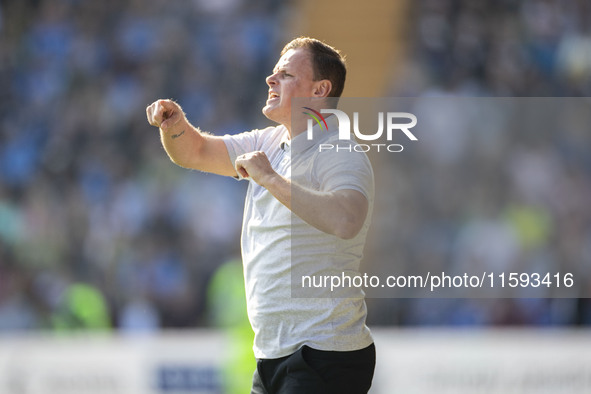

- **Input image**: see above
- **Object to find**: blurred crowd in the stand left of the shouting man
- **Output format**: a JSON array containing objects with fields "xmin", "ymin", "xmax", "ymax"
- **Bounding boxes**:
[{"xmin": 0, "ymin": 0, "xmax": 285, "ymax": 331}]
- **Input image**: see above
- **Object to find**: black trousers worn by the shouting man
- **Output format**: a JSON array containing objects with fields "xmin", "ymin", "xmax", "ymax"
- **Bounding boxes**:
[{"xmin": 251, "ymin": 344, "xmax": 376, "ymax": 394}]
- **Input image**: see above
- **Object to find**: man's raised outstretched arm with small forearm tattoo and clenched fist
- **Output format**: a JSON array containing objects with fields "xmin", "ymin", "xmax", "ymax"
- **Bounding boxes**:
[{"xmin": 146, "ymin": 100, "xmax": 236, "ymax": 176}]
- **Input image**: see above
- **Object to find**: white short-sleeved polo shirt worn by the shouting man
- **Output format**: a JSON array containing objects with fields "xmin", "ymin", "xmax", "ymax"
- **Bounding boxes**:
[{"xmin": 224, "ymin": 117, "xmax": 374, "ymax": 358}]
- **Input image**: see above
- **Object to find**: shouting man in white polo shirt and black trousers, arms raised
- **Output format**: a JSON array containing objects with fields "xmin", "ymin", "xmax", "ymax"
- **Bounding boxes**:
[{"xmin": 146, "ymin": 37, "xmax": 375, "ymax": 394}]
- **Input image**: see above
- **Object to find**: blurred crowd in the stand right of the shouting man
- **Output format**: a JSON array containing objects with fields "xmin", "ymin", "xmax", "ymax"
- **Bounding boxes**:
[{"xmin": 370, "ymin": 0, "xmax": 591, "ymax": 326}]
